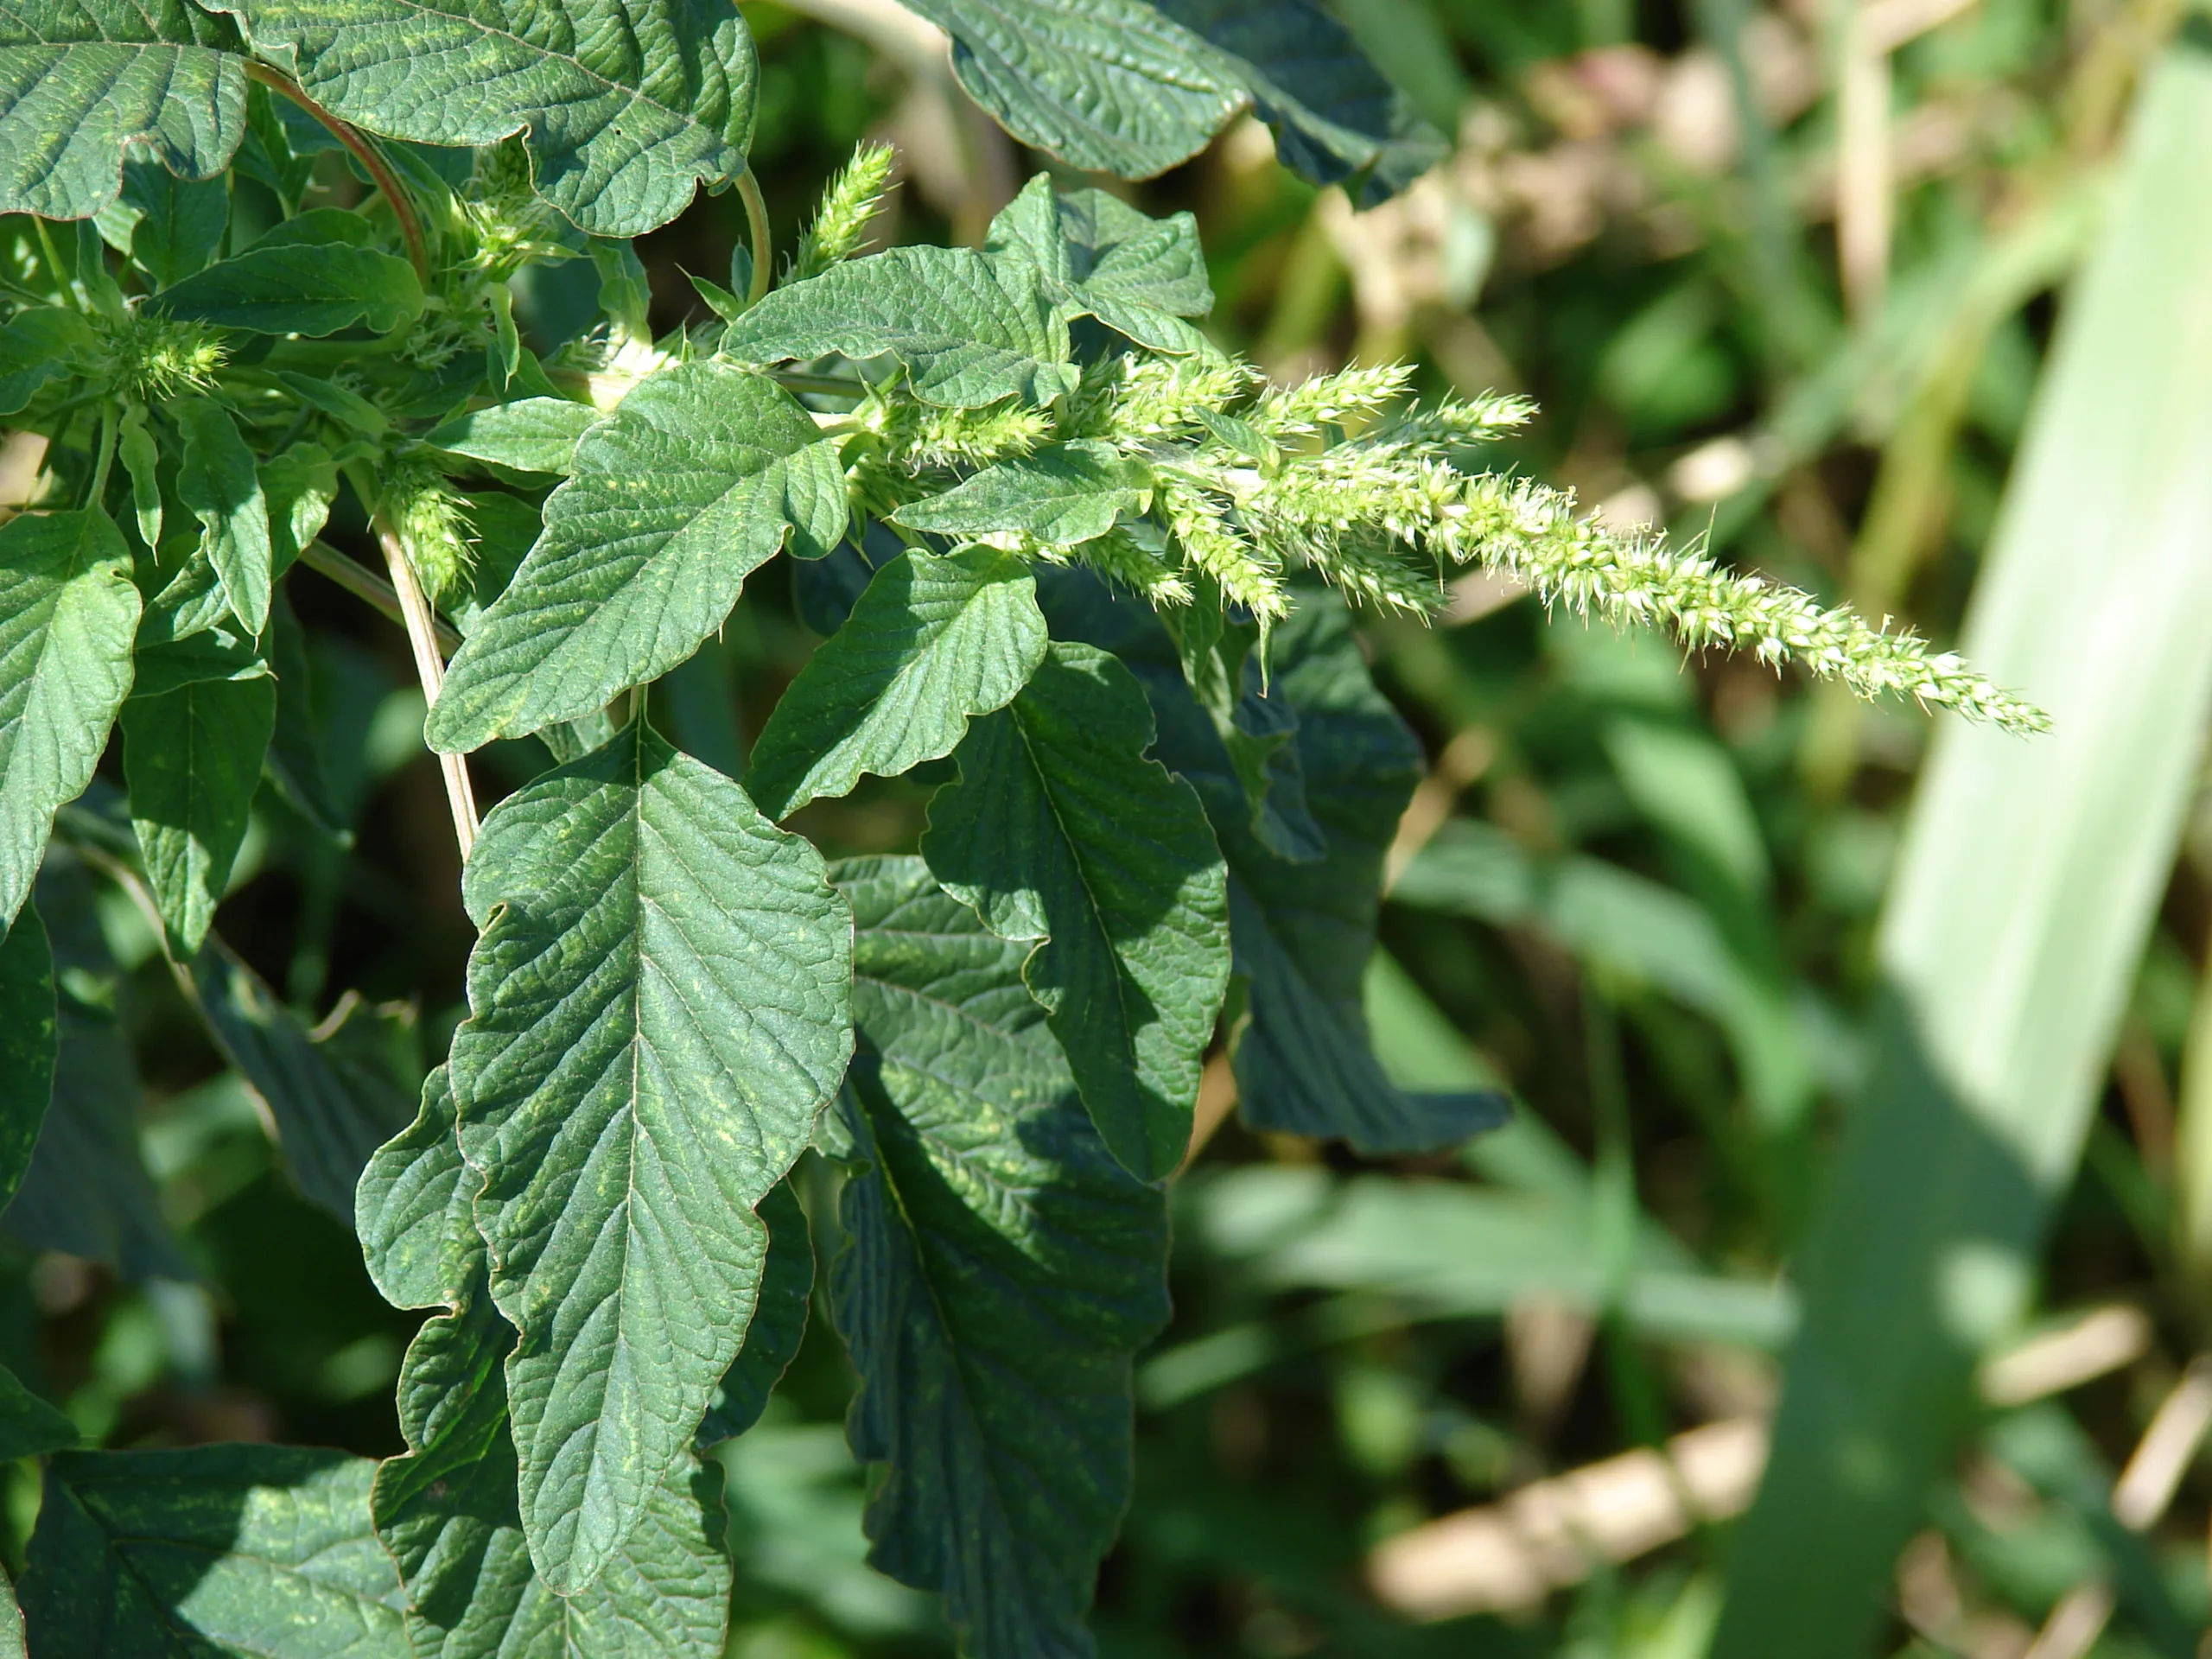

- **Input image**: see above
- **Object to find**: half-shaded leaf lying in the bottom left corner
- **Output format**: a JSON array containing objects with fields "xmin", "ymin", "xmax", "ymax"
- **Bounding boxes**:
[{"xmin": 22, "ymin": 1446, "xmax": 407, "ymax": 1659}]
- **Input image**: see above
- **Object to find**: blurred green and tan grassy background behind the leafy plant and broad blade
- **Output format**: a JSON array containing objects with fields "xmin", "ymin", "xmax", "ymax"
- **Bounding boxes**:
[{"xmin": 13, "ymin": 0, "xmax": 2212, "ymax": 1659}]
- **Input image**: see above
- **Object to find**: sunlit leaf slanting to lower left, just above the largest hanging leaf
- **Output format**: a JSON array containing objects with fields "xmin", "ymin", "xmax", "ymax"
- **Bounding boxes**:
[{"xmin": 429, "ymin": 363, "xmax": 845, "ymax": 750}]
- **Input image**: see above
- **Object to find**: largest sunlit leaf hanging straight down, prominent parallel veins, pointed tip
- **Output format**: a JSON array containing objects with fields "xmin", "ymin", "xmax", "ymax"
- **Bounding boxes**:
[{"xmin": 451, "ymin": 721, "xmax": 852, "ymax": 1595}]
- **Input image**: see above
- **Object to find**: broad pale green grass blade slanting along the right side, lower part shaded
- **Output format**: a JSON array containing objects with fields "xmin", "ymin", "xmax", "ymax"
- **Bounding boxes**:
[{"xmin": 1714, "ymin": 41, "xmax": 2212, "ymax": 1659}]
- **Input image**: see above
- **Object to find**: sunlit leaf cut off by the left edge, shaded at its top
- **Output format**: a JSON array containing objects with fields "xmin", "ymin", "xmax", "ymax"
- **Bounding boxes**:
[{"xmin": 0, "ymin": 506, "xmax": 139, "ymax": 938}]
